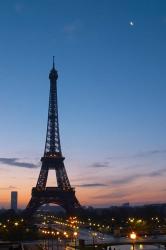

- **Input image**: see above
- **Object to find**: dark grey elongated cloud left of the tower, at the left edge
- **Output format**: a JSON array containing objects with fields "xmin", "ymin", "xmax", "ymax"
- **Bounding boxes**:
[{"xmin": 0, "ymin": 158, "xmax": 39, "ymax": 168}]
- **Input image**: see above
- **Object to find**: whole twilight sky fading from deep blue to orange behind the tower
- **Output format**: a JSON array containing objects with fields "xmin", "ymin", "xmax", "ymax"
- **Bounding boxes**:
[{"xmin": 0, "ymin": 0, "xmax": 166, "ymax": 207}]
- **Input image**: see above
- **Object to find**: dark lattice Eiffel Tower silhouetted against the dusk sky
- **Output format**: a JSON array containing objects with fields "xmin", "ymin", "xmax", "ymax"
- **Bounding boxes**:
[{"xmin": 24, "ymin": 57, "xmax": 81, "ymax": 216}]
